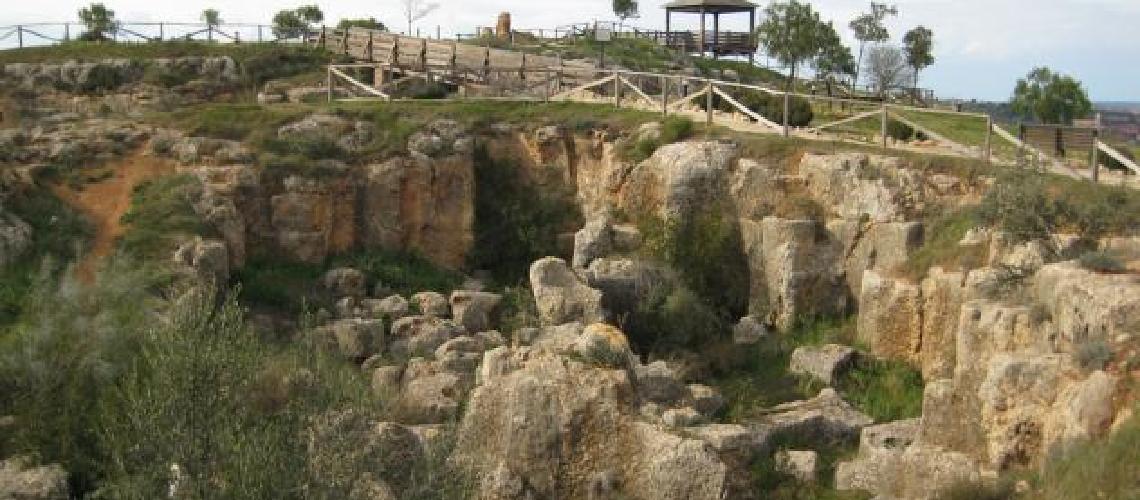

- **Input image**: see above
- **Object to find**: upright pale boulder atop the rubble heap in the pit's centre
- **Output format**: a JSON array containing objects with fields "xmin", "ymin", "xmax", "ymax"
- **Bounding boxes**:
[{"xmin": 530, "ymin": 257, "xmax": 606, "ymax": 325}]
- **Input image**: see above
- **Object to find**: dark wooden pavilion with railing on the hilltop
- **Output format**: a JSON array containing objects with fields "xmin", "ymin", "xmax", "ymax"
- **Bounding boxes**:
[{"xmin": 665, "ymin": 0, "xmax": 758, "ymax": 60}]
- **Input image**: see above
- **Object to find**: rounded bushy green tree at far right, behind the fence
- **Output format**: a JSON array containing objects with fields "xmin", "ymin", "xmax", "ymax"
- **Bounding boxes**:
[{"xmin": 1010, "ymin": 67, "xmax": 1092, "ymax": 125}]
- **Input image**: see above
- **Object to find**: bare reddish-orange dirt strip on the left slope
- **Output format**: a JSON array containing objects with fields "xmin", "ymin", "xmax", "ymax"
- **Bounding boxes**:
[{"xmin": 52, "ymin": 150, "xmax": 174, "ymax": 282}]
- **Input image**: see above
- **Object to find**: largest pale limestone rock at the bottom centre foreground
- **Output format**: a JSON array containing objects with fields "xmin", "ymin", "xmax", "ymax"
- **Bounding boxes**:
[{"xmin": 453, "ymin": 347, "xmax": 726, "ymax": 500}]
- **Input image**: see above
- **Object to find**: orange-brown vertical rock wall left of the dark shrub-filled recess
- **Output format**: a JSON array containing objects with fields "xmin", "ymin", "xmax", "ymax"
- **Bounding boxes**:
[{"xmin": 163, "ymin": 116, "xmax": 475, "ymax": 269}]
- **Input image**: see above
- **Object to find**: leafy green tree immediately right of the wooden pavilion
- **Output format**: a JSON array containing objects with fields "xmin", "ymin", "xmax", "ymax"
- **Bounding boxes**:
[{"xmin": 757, "ymin": 0, "xmax": 825, "ymax": 132}]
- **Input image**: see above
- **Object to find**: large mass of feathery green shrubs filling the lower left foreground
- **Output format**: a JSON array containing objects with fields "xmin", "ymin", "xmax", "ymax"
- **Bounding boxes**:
[{"xmin": 0, "ymin": 262, "xmax": 424, "ymax": 498}]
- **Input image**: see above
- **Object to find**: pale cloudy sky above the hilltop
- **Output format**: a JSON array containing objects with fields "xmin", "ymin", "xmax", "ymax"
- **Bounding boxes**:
[{"xmin": 0, "ymin": 0, "xmax": 1140, "ymax": 101}]
